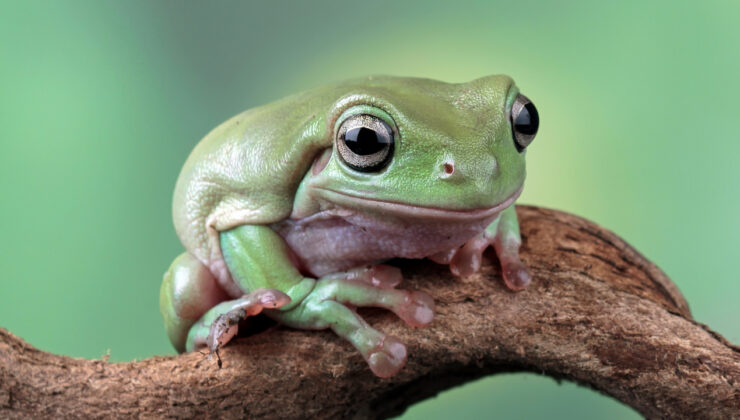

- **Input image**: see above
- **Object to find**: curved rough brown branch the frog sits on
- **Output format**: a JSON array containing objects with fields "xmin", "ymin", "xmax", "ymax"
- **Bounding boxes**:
[{"xmin": 0, "ymin": 207, "xmax": 740, "ymax": 418}]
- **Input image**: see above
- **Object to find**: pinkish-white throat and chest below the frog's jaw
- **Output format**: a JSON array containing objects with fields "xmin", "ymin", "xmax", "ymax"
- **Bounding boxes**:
[{"xmin": 272, "ymin": 212, "xmax": 498, "ymax": 277}]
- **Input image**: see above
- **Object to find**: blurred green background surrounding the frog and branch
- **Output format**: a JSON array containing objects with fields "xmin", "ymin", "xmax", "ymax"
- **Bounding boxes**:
[{"xmin": 0, "ymin": 0, "xmax": 740, "ymax": 419}]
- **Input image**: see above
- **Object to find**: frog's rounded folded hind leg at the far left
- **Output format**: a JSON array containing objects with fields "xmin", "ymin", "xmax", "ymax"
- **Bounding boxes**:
[{"xmin": 159, "ymin": 253, "xmax": 229, "ymax": 353}]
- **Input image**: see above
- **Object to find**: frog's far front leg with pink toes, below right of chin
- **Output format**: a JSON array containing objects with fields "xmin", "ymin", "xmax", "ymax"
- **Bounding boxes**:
[{"xmin": 442, "ymin": 205, "xmax": 532, "ymax": 291}]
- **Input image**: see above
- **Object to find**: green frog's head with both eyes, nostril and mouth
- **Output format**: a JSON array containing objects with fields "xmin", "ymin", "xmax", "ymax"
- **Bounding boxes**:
[{"xmin": 304, "ymin": 76, "xmax": 538, "ymax": 219}]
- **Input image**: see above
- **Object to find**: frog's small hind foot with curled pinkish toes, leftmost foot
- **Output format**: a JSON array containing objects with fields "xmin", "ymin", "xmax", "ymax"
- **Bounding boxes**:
[{"xmin": 186, "ymin": 289, "xmax": 290, "ymax": 356}]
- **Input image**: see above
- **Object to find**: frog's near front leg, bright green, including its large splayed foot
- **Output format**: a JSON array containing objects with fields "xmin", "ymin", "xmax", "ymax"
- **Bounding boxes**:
[{"xmin": 221, "ymin": 226, "xmax": 434, "ymax": 377}]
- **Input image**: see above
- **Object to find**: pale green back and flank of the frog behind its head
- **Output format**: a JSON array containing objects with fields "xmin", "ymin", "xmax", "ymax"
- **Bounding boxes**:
[{"xmin": 172, "ymin": 88, "xmax": 331, "ymax": 274}]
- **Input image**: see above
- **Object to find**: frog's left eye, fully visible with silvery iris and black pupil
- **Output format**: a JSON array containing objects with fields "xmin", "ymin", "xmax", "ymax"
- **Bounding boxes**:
[{"xmin": 337, "ymin": 114, "xmax": 393, "ymax": 172}]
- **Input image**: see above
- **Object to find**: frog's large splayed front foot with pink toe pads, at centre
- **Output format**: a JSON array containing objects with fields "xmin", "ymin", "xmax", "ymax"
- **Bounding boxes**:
[{"xmin": 269, "ymin": 266, "xmax": 434, "ymax": 378}]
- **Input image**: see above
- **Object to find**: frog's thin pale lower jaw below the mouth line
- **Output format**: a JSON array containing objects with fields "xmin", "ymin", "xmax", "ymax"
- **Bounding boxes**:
[{"xmin": 316, "ymin": 185, "xmax": 524, "ymax": 221}]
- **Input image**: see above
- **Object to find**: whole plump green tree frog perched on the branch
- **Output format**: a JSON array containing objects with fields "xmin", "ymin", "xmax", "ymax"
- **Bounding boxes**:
[{"xmin": 160, "ymin": 75, "xmax": 539, "ymax": 378}]
